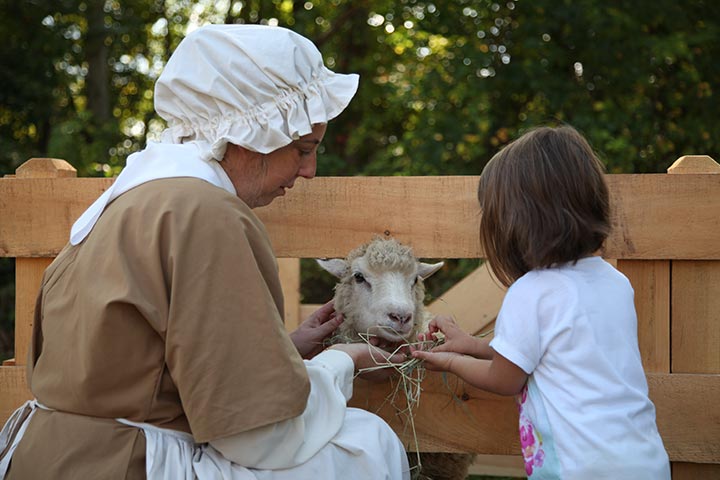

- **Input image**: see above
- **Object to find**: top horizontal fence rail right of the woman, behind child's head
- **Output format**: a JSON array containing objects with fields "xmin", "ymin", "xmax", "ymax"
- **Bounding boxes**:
[{"xmin": 258, "ymin": 174, "xmax": 720, "ymax": 259}]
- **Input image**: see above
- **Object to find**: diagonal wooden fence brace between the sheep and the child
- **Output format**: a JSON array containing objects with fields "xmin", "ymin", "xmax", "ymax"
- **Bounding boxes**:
[{"xmin": 428, "ymin": 263, "xmax": 507, "ymax": 335}]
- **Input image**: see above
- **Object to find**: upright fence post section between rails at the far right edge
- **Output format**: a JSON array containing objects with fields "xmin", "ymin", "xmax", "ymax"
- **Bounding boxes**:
[{"xmin": 672, "ymin": 260, "xmax": 720, "ymax": 374}]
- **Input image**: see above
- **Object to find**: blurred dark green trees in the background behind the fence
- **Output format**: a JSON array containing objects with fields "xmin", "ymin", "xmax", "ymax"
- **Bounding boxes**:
[{"xmin": 0, "ymin": 0, "xmax": 720, "ymax": 358}]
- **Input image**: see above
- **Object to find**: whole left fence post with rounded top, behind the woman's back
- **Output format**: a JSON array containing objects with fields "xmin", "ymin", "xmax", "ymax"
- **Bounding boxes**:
[{"xmin": 8, "ymin": 158, "xmax": 77, "ymax": 366}]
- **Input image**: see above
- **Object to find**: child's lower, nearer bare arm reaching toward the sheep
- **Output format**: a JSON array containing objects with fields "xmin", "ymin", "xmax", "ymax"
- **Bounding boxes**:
[{"xmin": 413, "ymin": 349, "xmax": 528, "ymax": 395}]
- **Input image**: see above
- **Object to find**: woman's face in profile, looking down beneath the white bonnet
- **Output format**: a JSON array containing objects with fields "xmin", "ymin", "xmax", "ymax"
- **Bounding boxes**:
[{"xmin": 220, "ymin": 124, "xmax": 327, "ymax": 208}]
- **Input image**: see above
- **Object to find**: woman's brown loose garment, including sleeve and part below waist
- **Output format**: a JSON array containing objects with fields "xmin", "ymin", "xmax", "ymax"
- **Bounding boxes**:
[{"xmin": 9, "ymin": 178, "xmax": 309, "ymax": 479}]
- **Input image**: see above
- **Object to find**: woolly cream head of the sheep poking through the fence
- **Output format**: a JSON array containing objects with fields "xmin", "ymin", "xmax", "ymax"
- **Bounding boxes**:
[{"xmin": 318, "ymin": 238, "xmax": 443, "ymax": 342}]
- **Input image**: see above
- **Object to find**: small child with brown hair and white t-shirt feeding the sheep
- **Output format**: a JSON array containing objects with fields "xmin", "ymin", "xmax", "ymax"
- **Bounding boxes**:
[{"xmin": 413, "ymin": 127, "xmax": 670, "ymax": 480}]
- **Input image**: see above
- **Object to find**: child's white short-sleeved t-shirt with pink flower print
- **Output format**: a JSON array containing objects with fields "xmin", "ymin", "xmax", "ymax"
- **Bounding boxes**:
[{"xmin": 490, "ymin": 257, "xmax": 670, "ymax": 480}]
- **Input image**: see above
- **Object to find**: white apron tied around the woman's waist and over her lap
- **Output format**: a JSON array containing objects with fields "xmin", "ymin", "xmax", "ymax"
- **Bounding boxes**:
[{"xmin": 0, "ymin": 400, "xmax": 410, "ymax": 480}]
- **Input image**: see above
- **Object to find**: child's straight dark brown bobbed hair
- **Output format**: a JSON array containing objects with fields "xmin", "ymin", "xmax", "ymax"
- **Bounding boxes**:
[{"xmin": 478, "ymin": 126, "xmax": 610, "ymax": 286}]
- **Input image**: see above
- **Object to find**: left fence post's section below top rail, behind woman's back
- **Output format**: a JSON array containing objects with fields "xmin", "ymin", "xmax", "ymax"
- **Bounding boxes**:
[{"xmin": 15, "ymin": 258, "xmax": 53, "ymax": 365}]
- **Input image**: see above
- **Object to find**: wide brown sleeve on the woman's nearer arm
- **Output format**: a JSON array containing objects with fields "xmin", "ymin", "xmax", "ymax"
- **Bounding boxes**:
[{"xmin": 163, "ymin": 191, "xmax": 310, "ymax": 442}]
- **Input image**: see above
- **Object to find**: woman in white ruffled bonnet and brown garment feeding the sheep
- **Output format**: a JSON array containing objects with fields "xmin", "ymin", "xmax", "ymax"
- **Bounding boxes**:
[{"xmin": 0, "ymin": 25, "xmax": 409, "ymax": 479}]
